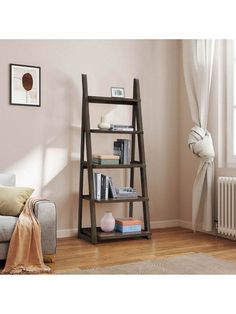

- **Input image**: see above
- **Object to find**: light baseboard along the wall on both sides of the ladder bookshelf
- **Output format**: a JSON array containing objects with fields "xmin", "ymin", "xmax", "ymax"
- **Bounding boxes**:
[{"xmin": 57, "ymin": 219, "xmax": 192, "ymax": 239}]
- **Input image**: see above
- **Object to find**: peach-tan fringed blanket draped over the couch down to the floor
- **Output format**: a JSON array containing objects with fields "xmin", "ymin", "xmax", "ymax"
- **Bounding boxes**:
[{"xmin": 2, "ymin": 197, "xmax": 51, "ymax": 274}]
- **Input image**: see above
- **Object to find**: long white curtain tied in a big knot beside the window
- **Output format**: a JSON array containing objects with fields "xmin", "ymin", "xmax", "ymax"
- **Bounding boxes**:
[{"xmin": 183, "ymin": 40, "xmax": 215, "ymax": 231}]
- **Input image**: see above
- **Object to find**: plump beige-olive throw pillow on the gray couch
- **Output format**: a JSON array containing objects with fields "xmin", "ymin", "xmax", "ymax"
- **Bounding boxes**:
[{"xmin": 0, "ymin": 186, "xmax": 34, "ymax": 216}]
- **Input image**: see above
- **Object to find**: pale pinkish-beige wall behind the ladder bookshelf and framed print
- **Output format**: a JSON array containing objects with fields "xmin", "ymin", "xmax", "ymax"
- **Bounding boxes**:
[{"xmin": 0, "ymin": 40, "xmax": 179, "ymax": 235}]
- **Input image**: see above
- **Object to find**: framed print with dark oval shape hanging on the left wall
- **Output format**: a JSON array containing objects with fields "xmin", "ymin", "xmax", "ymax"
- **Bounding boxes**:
[{"xmin": 10, "ymin": 64, "xmax": 41, "ymax": 107}]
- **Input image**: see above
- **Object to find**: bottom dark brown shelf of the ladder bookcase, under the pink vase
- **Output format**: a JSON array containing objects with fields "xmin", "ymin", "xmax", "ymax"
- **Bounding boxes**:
[{"xmin": 81, "ymin": 227, "xmax": 151, "ymax": 241}]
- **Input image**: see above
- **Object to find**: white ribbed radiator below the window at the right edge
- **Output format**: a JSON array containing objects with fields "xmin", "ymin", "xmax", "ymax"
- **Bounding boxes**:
[{"xmin": 218, "ymin": 177, "xmax": 236, "ymax": 237}]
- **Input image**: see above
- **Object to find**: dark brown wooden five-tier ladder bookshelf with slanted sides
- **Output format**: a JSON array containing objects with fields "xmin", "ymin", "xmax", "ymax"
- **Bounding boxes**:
[{"xmin": 78, "ymin": 74, "xmax": 151, "ymax": 244}]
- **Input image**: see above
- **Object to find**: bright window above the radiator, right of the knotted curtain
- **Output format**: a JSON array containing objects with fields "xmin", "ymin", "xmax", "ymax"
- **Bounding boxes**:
[{"xmin": 226, "ymin": 40, "xmax": 236, "ymax": 167}]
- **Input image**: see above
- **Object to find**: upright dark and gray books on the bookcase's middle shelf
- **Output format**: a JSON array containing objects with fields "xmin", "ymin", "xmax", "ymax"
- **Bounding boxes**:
[{"xmin": 113, "ymin": 139, "xmax": 131, "ymax": 164}]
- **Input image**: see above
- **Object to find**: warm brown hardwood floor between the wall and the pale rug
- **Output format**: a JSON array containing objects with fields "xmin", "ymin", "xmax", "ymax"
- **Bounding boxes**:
[{"xmin": 49, "ymin": 228, "xmax": 236, "ymax": 273}]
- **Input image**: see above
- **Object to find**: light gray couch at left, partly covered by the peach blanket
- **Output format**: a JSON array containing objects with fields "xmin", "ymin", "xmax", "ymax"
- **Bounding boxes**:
[{"xmin": 0, "ymin": 173, "xmax": 57, "ymax": 259}]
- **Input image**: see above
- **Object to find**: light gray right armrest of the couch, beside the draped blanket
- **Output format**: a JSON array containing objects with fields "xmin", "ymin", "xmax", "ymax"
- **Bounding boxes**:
[{"xmin": 34, "ymin": 200, "xmax": 57, "ymax": 254}]
